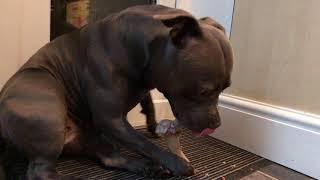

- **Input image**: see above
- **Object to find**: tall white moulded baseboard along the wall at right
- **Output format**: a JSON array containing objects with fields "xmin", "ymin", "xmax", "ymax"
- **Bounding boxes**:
[{"xmin": 213, "ymin": 95, "xmax": 320, "ymax": 179}]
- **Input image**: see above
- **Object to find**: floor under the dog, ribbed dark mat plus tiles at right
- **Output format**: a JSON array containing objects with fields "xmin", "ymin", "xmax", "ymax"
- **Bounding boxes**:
[{"xmin": 5, "ymin": 128, "xmax": 312, "ymax": 180}]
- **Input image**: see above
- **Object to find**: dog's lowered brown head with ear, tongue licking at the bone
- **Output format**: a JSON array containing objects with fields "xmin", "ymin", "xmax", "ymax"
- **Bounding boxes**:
[{"xmin": 154, "ymin": 10, "xmax": 233, "ymax": 135}]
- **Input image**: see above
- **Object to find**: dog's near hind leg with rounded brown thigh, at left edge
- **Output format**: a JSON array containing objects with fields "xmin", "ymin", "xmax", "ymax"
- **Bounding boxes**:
[{"xmin": 0, "ymin": 70, "xmax": 81, "ymax": 180}]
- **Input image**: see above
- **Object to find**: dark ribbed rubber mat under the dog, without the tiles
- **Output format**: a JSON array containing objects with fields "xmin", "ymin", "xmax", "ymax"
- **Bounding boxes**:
[{"xmin": 7, "ymin": 128, "xmax": 263, "ymax": 180}]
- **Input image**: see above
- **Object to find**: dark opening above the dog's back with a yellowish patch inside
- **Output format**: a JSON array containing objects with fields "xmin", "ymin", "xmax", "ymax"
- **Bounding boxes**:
[{"xmin": 50, "ymin": 0, "xmax": 155, "ymax": 40}]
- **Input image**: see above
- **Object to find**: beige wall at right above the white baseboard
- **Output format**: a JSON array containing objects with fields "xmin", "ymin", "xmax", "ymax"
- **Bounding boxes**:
[{"xmin": 226, "ymin": 0, "xmax": 320, "ymax": 115}]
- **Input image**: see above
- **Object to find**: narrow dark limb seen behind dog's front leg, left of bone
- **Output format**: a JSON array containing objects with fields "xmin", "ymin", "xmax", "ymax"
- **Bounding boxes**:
[{"xmin": 140, "ymin": 92, "xmax": 158, "ymax": 137}]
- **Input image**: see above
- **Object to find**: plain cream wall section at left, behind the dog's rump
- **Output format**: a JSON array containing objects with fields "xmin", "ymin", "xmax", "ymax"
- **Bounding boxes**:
[{"xmin": 0, "ymin": 0, "xmax": 50, "ymax": 88}]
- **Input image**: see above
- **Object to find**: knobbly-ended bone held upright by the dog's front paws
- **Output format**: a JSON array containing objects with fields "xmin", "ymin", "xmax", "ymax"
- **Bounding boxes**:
[{"xmin": 156, "ymin": 119, "xmax": 190, "ymax": 162}]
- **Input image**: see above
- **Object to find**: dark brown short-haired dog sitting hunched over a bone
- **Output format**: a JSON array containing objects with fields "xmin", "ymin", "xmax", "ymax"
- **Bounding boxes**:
[{"xmin": 0, "ymin": 5, "xmax": 233, "ymax": 180}]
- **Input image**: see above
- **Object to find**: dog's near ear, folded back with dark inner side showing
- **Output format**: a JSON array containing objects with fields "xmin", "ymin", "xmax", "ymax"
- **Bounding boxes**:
[{"xmin": 153, "ymin": 14, "xmax": 201, "ymax": 47}]
